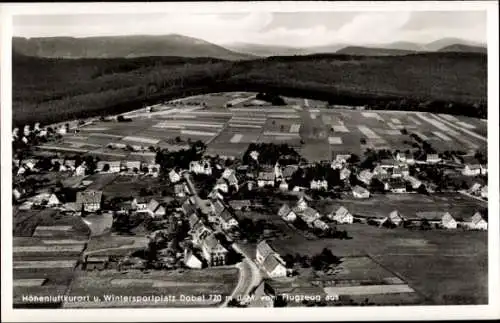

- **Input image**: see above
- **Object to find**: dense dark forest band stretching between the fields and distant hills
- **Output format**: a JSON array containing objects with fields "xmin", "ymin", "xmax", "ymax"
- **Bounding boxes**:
[{"xmin": 13, "ymin": 53, "xmax": 487, "ymax": 125}]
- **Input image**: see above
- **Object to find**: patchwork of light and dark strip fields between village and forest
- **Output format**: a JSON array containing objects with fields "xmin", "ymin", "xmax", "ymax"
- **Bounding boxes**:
[{"xmin": 34, "ymin": 93, "xmax": 487, "ymax": 162}]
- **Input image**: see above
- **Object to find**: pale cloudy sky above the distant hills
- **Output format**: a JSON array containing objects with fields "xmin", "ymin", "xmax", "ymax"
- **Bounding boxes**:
[{"xmin": 13, "ymin": 11, "xmax": 487, "ymax": 47}]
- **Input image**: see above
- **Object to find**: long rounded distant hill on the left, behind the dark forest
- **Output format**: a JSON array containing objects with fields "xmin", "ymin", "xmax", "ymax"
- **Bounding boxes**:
[{"xmin": 12, "ymin": 34, "xmax": 255, "ymax": 60}]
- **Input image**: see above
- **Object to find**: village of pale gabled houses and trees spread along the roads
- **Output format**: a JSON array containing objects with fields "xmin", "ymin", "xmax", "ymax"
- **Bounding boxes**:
[{"xmin": 12, "ymin": 92, "xmax": 488, "ymax": 306}]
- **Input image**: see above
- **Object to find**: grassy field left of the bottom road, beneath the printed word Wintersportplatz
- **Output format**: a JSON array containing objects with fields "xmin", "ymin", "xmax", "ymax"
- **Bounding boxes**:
[{"xmin": 64, "ymin": 268, "xmax": 238, "ymax": 308}]
